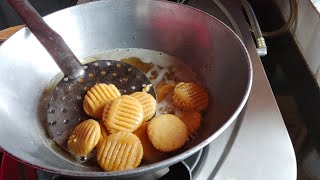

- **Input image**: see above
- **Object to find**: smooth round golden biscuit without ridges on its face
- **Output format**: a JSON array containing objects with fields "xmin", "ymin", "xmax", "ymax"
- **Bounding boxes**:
[{"xmin": 148, "ymin": 114, "xmax": 188, "ymax": 152}]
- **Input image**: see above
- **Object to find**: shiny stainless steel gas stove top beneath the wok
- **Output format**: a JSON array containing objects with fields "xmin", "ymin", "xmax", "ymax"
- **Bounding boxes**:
[{"xmin": 2, "ymin": 0, "xmax": 297, "ymax": 180}]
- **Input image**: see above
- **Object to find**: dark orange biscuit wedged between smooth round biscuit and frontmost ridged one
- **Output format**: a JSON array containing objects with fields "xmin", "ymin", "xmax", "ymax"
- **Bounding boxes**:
[{"xmin": 134, "ymin": 122, "xmax": 166, "ymax": 163}]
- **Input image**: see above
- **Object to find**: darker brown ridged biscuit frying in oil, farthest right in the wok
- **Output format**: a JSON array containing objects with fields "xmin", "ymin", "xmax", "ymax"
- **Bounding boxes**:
[{"xmin": 172, "ymin": 82, "xmax": 209, "ymax": 111}]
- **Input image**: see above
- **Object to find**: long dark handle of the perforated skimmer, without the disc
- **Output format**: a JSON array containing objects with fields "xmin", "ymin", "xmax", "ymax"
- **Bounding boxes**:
[{"xmin": 8, "ymin": 0, "xmax": 84, "ymax": 78}]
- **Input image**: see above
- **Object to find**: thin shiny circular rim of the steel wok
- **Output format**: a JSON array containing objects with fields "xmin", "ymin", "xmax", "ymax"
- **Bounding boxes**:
[{"xmin": 0, "ymin": 0, "xmax": 253, "ymax": 177}]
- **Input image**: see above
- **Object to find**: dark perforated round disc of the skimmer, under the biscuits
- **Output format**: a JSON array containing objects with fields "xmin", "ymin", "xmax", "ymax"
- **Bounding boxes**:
[{"xmin": 47, "ymin": 60, "xmax": 156, "ymax": 149}]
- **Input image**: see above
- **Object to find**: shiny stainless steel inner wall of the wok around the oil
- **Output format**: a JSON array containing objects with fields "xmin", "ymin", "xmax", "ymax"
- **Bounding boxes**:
[{"xmin": 0, "ymin": 0, "xmax": 252, "ymax": 177}]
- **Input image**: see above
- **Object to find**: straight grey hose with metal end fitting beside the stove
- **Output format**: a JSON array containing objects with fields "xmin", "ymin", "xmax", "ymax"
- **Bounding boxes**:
[{"xmin": 241, "ymin": 0, "xmax": 268, "ymax": 56}]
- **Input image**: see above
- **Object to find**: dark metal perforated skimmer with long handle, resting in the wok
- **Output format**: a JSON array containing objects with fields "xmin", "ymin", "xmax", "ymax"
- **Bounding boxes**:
[{"xmin": 8, "ymin": 0, "xmax": 156, "ymax": 149}]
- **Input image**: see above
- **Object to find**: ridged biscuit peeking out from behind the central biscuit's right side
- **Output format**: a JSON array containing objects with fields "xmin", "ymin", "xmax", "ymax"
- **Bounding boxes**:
[{"xmin": 130, "ymin": 92, "xmax": 157, "ymax": 121}]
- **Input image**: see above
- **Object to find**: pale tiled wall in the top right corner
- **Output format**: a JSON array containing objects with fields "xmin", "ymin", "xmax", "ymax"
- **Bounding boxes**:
[{"xmin": 275, "ymin": 0, "xmax": 320, "ymax": 85}]
